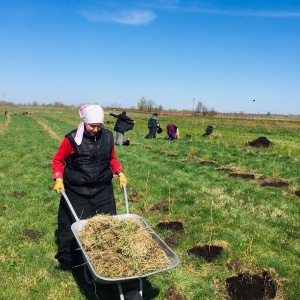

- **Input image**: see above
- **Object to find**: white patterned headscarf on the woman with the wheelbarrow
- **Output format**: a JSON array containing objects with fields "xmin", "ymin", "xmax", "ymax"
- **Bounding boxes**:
[{"xmin": 75, "ymin": 104, "xmax": 104, "ymax": 146}]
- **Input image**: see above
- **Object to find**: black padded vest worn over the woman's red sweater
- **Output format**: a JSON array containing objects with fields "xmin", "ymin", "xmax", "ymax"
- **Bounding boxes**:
[{"xmin": 64, "ymin": 128, "xmax": 114, "ymax": 195}]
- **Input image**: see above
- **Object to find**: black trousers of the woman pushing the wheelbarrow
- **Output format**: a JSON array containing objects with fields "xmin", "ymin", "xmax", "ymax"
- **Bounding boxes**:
[{"xmin": 55, "ymin": 184, "xmax": 116, "ymax": 263}]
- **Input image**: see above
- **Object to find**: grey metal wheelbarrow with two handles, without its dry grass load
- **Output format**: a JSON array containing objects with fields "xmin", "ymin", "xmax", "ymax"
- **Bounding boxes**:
[{"xmin": 61, "ymin": 186, "xmax": 179, "ymax": 300}]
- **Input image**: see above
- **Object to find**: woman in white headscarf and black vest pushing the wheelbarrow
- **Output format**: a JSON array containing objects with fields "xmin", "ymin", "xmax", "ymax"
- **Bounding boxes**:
[{"xmin": 52, "ymin": 105, "xmax": 127, "ymax": 266}]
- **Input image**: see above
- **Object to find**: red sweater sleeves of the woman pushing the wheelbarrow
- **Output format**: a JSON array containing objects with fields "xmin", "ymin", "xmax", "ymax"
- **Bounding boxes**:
[{"xmin": 52, "ymin": 137, "xmax": 122, "ymax": 179}]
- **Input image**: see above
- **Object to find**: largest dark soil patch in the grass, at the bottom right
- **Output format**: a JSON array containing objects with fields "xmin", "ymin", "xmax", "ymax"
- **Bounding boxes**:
[{"xmin": 226, "ymin": 271, "xmax": 277, "ymax": 300}]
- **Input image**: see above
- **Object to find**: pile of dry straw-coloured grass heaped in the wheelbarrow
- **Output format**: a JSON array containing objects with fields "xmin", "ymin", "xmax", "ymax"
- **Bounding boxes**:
[{"xmin": 78, "ymin": 215, "xmax": 171, "ymax": 279}]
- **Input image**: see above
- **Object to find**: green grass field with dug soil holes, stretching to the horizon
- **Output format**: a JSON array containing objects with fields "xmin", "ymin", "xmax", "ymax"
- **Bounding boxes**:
[{"xmin": 0, "ymin": 107, "xmax": 300, "ymax": 300}]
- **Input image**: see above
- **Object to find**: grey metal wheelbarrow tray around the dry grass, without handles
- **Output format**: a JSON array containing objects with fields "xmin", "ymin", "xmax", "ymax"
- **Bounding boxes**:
[{"xmin": 71, "ymin": 214, "xmax": 179, "ymax": 284}]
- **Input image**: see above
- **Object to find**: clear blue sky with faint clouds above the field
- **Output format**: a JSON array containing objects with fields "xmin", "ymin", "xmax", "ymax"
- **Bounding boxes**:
[{"xmin": 0, "ymin": 0, "xmax": 300, "ymax": 114}]
